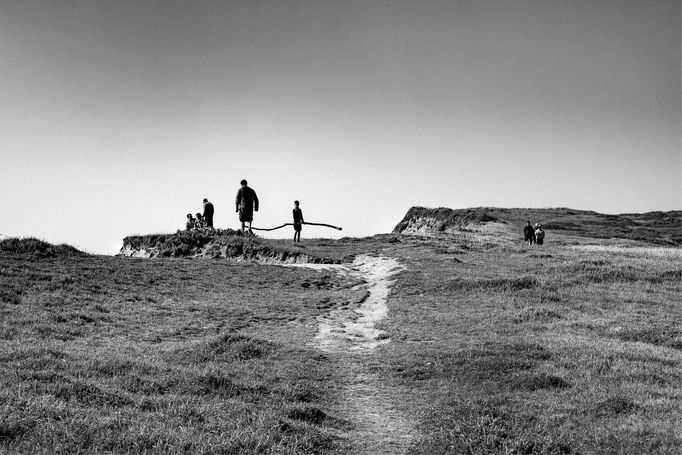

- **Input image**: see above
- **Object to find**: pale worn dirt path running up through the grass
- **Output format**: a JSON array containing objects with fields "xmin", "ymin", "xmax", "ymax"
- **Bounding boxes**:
[{"xmin": 288, "ymin": 255, "xmax": 414, "ymax": 455}]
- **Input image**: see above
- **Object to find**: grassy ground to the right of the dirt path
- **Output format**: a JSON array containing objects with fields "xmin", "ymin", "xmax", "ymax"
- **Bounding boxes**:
[{"xmin": 376, "ymin": 233, "xmax": 682, "ymax": 454}]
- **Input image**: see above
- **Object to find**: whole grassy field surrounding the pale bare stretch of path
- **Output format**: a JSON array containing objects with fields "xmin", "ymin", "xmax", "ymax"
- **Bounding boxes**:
[{"xmin": 0, "ymin": 219, "xmax": 682, "ymax": 455}]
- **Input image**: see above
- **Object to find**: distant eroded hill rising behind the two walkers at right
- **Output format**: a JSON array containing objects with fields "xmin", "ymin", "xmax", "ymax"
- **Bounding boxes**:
[{"xmin": 393, "ymin": 207, "xmax": 682, "ymax": 246}]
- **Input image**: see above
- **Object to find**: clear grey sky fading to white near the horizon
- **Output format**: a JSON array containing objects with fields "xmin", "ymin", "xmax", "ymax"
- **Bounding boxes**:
[{"xmin": 0, "ymin": 0, "xmax": 682, "ymax": 254}]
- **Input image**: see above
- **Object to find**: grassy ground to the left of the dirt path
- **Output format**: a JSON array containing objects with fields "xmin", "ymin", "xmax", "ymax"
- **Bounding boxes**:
[{"xmin": 0, "ymin": 246, "xmax": 364, "ymax": 454}]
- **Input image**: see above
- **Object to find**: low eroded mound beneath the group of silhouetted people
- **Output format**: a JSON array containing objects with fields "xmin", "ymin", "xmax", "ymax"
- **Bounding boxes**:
[{"xmin": 118, "ymin": 229, "xmax": 340, "ymax": 264}]
